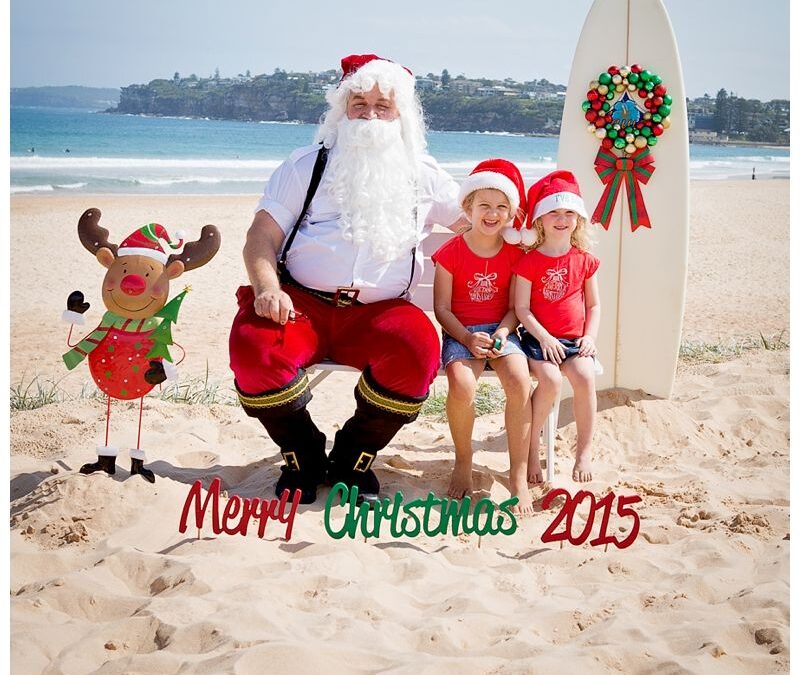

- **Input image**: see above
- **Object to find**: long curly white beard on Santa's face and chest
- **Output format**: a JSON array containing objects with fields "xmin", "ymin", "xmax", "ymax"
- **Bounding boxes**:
[{"xmin": 325, "ymin": 118, "xmax": 418, "ymax": 262}]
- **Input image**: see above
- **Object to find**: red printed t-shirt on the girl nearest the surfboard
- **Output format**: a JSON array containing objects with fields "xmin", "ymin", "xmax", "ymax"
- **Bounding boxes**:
[{"xmin": 514, "ymin": 246, "xmax": 600, "ymax": 339}]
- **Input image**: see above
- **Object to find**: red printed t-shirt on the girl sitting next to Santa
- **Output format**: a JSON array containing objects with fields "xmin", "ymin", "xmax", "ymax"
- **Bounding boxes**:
[{"xmin": 431, "ymin": 235, "xmax": 523, "ymax": 326}]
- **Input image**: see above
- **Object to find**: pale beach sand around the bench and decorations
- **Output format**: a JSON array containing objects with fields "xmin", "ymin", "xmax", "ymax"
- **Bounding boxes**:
[{"xmin": 10, "ymin": 181, "xmax": 789, "ymax": 674}]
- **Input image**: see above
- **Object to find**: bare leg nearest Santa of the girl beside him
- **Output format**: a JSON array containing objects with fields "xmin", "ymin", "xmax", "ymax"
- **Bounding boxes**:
[{"xmin": 445, "ymin": 360, "xmax": 485, "ymax": 499}]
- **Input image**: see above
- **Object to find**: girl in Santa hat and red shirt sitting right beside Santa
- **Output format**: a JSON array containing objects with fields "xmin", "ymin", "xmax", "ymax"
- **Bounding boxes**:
[{"xmin": 432, "ymin": 159, "xmax": 533, "ymax": 515}]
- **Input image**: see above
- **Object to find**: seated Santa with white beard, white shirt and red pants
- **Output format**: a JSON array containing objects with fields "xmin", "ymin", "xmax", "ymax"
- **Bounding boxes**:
[{"xmin": 230, "ymin": 54, "xmax": 466, "ymax": 503}]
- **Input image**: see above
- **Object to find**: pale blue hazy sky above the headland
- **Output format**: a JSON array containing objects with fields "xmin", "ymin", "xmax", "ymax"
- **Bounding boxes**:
[{"xmin": 10, "ymin": 0, "xmax": 789, "ymax": 100}]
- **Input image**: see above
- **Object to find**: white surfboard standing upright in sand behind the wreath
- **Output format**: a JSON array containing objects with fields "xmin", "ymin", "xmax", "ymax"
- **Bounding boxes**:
[{"xmin": 558, "ymin": 0, "xmax": 689, "ymax": 398}]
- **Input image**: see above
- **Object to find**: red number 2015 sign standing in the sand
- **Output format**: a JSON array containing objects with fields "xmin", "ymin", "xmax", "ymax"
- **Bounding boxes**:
[{"xmin": 542, "ymin": 488, "xmax": 642, "ymax": 548}]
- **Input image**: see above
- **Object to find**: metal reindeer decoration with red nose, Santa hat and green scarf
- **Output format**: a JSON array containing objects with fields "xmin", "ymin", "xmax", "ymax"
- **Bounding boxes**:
[{"xmin": 62, "ymin": 209, "xmax": 220, "ymax": 483}]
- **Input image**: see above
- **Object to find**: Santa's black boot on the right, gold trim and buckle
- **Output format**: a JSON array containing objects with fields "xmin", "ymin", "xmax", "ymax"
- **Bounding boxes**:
[{"xmin": 327, "ymin": 370, "xmax": 427, "ymax": 504}]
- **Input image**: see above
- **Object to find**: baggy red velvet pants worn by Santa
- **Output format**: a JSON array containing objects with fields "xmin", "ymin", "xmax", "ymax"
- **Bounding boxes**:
[{"xmin": 230, "ymin": 286, "xmax": 439, "ymax": 398}]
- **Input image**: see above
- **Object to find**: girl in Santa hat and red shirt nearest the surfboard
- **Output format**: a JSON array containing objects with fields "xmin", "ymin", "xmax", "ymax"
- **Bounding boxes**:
[{"xmin": 514, "ymin": 171, "xmax": 600, "ymax": 483}]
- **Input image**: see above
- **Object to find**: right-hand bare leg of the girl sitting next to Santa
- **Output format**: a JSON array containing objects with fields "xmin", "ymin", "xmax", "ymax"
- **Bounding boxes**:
[{"xmin": 491, "ymin": 354, "xmax": 533, "ymax": 516}]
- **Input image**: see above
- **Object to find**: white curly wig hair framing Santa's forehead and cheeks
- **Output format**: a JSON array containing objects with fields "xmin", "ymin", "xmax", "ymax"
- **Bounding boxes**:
[{"xmin": 316, "ymin": 55, "xmax": 427, "ymax": 159}]
